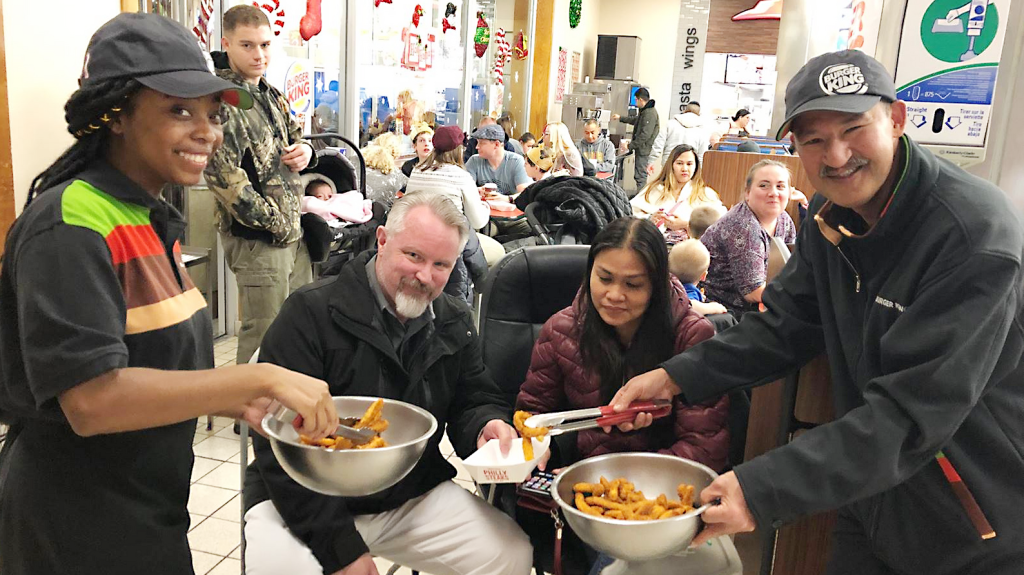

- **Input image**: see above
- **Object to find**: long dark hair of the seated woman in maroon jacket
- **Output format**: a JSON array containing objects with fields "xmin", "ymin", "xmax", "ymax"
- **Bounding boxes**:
[{"xmin": 575, "ymin": 217, "xmax": 676, "ymax": 404}]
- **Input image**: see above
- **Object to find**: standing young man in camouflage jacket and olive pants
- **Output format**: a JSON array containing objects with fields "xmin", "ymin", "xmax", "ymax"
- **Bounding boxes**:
[{"xmin": 205, "ymin": 5, "xmax": 315, "ymax": 363}]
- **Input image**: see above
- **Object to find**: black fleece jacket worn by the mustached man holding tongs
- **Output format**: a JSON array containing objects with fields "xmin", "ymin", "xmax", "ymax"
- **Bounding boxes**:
[{"xmin": 664, "ymin": 137, "xmax": 1024, "ymax": 573}]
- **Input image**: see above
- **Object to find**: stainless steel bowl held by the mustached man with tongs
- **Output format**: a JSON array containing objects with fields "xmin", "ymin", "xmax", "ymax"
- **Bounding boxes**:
[{"xmin": 551, "ymin": 453, "xmax": 718, "ymax": 561}]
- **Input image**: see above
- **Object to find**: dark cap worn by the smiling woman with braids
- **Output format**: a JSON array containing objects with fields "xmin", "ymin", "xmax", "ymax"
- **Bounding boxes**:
[{"xmin": 79, "ymin": 13, "xmax": 253, "ymax": 109}]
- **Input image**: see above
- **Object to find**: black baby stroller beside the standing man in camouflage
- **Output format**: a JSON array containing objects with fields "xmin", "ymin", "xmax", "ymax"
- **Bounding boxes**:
[{"xmin": 301, "ymin": 133, "xmax": 386, "ymax": 277}]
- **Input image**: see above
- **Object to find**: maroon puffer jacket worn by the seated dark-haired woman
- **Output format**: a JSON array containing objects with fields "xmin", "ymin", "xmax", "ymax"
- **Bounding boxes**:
[{"xmin": 516, "ymin": 277, "xmax": 729, "ymax": 471}]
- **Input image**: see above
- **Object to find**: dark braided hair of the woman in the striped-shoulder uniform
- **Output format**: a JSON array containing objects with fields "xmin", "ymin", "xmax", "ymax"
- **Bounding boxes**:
[{"xmin": 25, "ymin": 78, "xmax": 142, "ymax": 208}]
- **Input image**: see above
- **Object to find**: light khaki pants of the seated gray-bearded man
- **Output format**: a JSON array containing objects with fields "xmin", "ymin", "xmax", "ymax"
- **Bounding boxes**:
[{"xmin": 245, "ymin": 481, "xmax": 534, "ymax": 575}]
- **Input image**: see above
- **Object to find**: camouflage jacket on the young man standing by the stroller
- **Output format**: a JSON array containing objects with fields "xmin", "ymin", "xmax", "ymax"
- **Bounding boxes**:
[{"xmin": 204, "ymin": 58, "xmax": 316, "ymax": 246}]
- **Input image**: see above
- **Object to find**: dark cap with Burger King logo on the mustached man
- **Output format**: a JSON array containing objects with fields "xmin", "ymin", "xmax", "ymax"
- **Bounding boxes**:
[{"xmin": 775, "ymin": 50, "xmax": 896, "ymax": 140}]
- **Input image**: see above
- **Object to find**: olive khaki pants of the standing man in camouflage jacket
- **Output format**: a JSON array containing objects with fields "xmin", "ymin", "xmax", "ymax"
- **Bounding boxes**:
[{"xmin": 220, "ymin": 233, "xmax": 313, "ymax": 364}]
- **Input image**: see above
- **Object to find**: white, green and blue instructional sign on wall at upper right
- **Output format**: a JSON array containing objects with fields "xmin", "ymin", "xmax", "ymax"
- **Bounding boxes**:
[{"xmin": 896, "ymin": 0, "xmax": 1010, "ymax": 147}]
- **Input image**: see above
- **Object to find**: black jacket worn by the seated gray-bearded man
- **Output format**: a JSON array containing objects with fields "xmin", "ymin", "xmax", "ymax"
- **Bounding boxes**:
[{"xmin": 244, "ymin": 252, "xmax": 512, "ymax": 573}]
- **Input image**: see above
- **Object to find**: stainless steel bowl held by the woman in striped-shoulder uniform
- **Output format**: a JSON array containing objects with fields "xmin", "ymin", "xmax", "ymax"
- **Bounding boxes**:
[{"xmin": 263, "ymin": 396, "xmax": 437, "ymax": 497}]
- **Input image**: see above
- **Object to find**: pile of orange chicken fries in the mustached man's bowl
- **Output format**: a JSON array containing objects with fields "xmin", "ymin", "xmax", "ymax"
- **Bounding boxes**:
[{"xmin": 572, "ymin": 477, "xmax": 693, "ymax": 521}]
